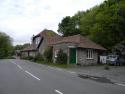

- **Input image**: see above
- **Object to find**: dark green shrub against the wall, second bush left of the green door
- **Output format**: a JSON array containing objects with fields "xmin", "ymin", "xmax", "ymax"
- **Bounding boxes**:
[{"xmin": 44, "ymin": 47, "xmax": 53, "ymax": 62}]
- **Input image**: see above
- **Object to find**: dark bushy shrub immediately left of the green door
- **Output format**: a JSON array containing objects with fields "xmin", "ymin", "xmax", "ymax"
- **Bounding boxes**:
[{"xmin": 56, "ymin": 49, "xmax": 67, "ymax": 64}]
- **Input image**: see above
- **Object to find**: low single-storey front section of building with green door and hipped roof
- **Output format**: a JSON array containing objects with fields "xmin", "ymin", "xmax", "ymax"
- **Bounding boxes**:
[{"xmin": 52, "ymin": 35, "xmax": 106, "ymax": 65}]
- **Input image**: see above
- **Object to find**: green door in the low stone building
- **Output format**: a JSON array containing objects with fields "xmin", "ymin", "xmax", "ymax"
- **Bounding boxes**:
[{"xmin": 69, "ymin": 48, "xmax": 76, "ymax": 64}]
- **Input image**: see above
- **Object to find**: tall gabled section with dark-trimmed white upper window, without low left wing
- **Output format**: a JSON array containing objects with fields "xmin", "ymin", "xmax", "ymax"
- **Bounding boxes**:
[{"xmin": 32, "ymin": 29, "xmax": 62, "ymax": 55}]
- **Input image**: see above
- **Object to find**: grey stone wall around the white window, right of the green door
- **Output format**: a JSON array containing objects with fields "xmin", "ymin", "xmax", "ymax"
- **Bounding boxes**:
[{"xmin": 77, "ymin": 48, "xmax": 98, "ymax": 65}]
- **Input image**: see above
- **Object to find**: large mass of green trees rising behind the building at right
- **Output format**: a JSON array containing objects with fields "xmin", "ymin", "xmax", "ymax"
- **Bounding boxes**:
[{"xmin": 58, "ymin": 0, "xmax": 125, "ymax": 50}]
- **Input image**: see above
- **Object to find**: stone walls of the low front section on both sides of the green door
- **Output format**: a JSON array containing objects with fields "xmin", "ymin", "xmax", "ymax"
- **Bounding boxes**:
[{"xmin": 53, "ymin": 43, "xmax": 98, "ymax": 65}]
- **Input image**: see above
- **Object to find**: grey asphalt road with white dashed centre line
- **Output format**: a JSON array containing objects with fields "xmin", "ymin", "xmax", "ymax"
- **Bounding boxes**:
[{"xmin": 0, "ymin": 59, "xmax": 125, "ymax": 94}]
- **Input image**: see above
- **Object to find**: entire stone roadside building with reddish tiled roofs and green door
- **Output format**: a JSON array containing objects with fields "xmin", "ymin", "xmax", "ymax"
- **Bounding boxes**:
[{"xmin": 22, "ymin": 29, "xmax": 106, "ymax": 65}]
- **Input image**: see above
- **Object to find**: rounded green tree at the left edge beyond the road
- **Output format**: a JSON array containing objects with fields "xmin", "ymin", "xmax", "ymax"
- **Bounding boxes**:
[{"xmin": 0, "ymin": 32, "xmax": 13, "ymax": 58}]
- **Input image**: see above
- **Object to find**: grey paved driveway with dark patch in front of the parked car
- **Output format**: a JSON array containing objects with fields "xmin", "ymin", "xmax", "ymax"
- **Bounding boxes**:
[{"xmin": 68, "ymin": 66, "xmax": 125, "ymax": 85}]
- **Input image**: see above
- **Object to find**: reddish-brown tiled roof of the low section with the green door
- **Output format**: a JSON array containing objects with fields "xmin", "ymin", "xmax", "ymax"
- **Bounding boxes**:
[{"xmin": 53, "ymin": 34, "xmax": 106, "ymax": 50}]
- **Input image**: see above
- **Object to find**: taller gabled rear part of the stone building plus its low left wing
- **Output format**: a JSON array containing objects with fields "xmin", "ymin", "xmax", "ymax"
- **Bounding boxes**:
[{"xmin": 21, "ymin": 29, "xmax": 61, "ymax": 56}]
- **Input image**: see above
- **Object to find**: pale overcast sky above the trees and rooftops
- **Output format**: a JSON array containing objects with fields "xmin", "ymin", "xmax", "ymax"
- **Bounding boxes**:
[{"xmin": 0, "ymin": 0, "xmax": 104, "ymax": 45}]
